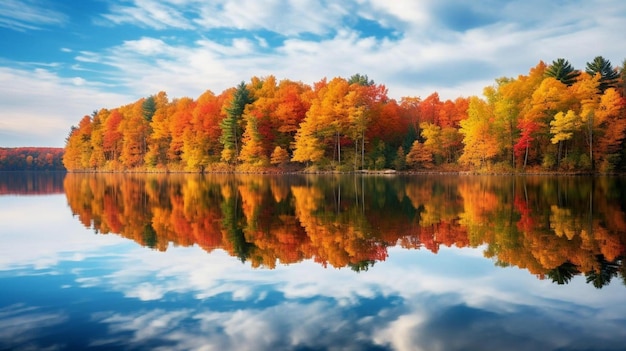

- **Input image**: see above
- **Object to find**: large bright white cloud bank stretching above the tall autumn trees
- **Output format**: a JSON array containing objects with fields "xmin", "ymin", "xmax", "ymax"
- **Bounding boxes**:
[{"xmin": 89, "ymin": 1, "xmax": 624, "ymax": 103}]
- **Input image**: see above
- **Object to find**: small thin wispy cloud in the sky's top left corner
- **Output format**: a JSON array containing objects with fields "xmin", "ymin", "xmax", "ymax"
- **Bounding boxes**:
[{"xmin": 0, "ymin": 0, "xmax": 68, "ymax": 31}]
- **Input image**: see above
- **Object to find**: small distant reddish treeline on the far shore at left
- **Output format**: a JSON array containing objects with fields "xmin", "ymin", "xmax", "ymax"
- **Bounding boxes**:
[{"xmin": 0, "ymin": 147, "xmax": 65, "ymax": 171}]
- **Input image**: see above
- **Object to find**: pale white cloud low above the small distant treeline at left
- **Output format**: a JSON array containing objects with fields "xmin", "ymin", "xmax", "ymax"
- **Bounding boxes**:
[{"xmin": 0, "ymin": 67, "xmax": 129, "ymax": 147}]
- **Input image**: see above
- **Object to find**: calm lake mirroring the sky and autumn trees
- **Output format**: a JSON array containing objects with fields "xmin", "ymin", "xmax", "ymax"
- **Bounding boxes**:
[{"xmin": 0, "ymin": 173, "xmax": 626, "ymax": 351}]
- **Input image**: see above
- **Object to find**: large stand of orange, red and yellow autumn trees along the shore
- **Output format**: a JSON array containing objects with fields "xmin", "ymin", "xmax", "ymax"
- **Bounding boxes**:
[{"xmin": 63, "ymin": 56, "xmax": 626, "ymax": 173}]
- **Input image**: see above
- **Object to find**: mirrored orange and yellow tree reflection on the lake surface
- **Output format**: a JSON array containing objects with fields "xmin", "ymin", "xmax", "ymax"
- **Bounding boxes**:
[{"xmin": 64, "ymin": 174, "xmax": 626, "ymax": 288}]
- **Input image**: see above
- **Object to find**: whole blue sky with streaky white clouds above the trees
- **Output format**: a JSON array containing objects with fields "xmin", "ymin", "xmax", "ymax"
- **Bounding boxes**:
[{"xmin": 0, "ymin": 0, "xmax": 626, "ymax": 147}]
